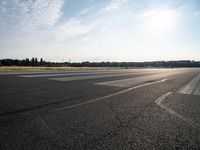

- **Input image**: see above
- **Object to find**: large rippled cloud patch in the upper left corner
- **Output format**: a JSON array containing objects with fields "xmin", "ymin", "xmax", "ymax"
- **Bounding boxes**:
[{"xmin": 0, "ymin": 0, "xmax": 64, "ymax": 30}]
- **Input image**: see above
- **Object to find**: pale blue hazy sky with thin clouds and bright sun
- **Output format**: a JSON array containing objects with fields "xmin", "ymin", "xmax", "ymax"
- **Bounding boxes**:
[{"xmin": 0, "ymin": 0, "xmax": 200, "ymax": 61}]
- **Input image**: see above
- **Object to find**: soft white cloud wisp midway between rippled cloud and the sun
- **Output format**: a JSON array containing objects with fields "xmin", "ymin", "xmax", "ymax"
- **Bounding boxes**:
[{"xmin": 55, "ymin": 19, "xmax": 94, "ymax": 41}]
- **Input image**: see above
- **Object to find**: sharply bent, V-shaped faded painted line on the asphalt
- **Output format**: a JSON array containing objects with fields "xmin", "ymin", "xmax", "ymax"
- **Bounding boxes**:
[{"xmin": 155, "ymin": 92, "xmax": 200, "ymax": 127}]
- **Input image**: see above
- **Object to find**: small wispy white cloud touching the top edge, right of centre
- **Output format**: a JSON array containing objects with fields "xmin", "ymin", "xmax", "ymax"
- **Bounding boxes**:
[{"xmin": 101, "ymin": 0, "xmax": 127, "ymax": 12}]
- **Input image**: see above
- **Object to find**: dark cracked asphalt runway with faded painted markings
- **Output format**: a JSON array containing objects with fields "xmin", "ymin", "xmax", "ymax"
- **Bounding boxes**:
[{"xmin": 0, "ymin": 68, "xmax": 200, "ymax": 150}]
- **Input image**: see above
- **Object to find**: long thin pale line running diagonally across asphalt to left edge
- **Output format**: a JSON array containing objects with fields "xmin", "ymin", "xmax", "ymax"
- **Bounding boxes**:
[{"xmin": 0, "ymin": 79, "xmax": 167, "ymax": 126}]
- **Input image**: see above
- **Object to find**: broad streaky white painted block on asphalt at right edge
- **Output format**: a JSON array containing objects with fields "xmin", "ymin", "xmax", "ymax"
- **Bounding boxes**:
[{"xmin": 177, "ymin": 73, "xmax": 200, "ymax": 95}]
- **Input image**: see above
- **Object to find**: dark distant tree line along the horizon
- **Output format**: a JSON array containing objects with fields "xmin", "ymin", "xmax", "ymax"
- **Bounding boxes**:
[{"xmin": 0, "ymin": 57, "xmax": 200, "ymax": 68}]
